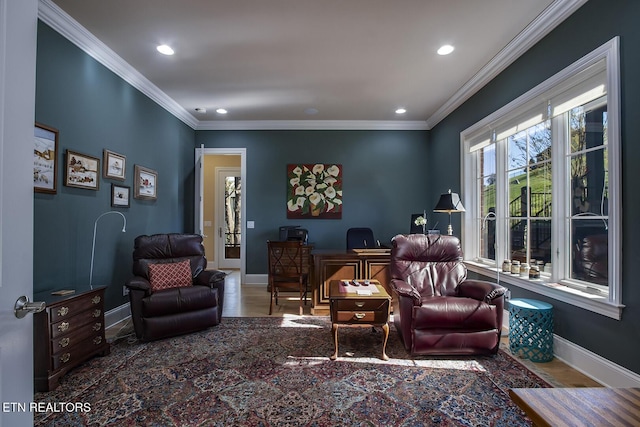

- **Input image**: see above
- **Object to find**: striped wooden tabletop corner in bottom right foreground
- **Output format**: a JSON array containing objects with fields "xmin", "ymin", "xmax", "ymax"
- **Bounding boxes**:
[{"xmin": 509, "ymin": 387, "xmax": 640, "ymax": 427}]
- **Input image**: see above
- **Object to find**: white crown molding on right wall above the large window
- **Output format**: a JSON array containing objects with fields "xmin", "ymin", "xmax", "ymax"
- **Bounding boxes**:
[{"xmin": 427, "ymin": 0, "xmax": 588, "ymax": 129}]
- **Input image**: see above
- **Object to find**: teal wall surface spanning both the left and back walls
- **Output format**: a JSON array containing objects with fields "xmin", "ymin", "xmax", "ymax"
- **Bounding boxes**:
[{"xmin": 34, "ymin": 23, "xmax": 430, "ymax": 309}]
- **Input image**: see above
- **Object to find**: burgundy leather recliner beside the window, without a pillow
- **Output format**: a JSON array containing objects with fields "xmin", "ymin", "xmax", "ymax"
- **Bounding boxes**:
[{"xmin": 389, "ymin": 234, "xmax": 506, "ymax": 355}]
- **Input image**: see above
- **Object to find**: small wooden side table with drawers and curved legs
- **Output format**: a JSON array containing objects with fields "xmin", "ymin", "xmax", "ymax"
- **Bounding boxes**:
[{"xmin": 329, "ymin": 280, "xmax": 391, "ymax": 360}]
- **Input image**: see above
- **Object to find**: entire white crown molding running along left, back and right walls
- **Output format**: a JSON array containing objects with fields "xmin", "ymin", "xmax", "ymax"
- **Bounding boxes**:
[{"xmin": 38, "ymin": 0, "xmax": 588, "ymax": 130}]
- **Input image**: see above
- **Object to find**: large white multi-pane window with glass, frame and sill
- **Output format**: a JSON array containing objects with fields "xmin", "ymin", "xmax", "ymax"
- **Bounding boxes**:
[{"xmin": 461, "ymin": 38, "xmax": 623, "ymax": 319}]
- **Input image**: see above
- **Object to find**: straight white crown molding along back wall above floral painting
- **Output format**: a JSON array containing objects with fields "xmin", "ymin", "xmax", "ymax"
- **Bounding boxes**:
[{"xmin": 196, "ymin": 120, "xmax": 428, "ymax": 130}]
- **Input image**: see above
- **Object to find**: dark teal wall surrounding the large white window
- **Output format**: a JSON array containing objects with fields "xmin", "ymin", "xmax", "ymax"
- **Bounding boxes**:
[{"xmin": 427, "ymin": 0, "xmax": 640, "ymax": 373}]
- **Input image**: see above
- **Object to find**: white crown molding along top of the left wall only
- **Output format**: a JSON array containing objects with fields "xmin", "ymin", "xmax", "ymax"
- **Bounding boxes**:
[{"xmin": 38, "ymin": 0, "xmax": 198, "ymax": 129}]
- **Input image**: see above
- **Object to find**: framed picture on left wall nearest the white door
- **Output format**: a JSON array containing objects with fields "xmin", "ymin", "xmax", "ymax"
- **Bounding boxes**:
[{"xmin": 33, "ymin": 123, "xmax": 58, "ymax": 194}]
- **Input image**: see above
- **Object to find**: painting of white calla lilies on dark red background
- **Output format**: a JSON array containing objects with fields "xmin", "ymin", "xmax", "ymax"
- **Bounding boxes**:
[{"xmin": 287, "ymin": 163, "xmax": 342, "ymax": 219}]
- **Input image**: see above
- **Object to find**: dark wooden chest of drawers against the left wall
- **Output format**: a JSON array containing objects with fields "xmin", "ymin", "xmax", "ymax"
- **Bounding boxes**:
[{"xmin": 33, "ymin": 288, "xmax": 110, "ymax": 391}]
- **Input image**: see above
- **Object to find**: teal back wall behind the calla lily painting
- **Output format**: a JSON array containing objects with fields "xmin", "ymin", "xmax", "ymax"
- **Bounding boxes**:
[{"xmin": 196, "ymin": 130, "xmax": 430, "ymax": 274}]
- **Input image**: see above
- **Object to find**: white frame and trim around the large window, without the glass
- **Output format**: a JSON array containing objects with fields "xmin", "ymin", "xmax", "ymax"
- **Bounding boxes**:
[{"xmin": 460, "ymin": 37, "xmax": 624, "ymax": 320}]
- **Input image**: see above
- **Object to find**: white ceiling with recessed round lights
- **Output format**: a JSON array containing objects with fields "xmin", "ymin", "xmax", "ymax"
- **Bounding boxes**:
[{"xmin": 40, "ymin": 0, "xmax": 586, "ymax": 129}]
